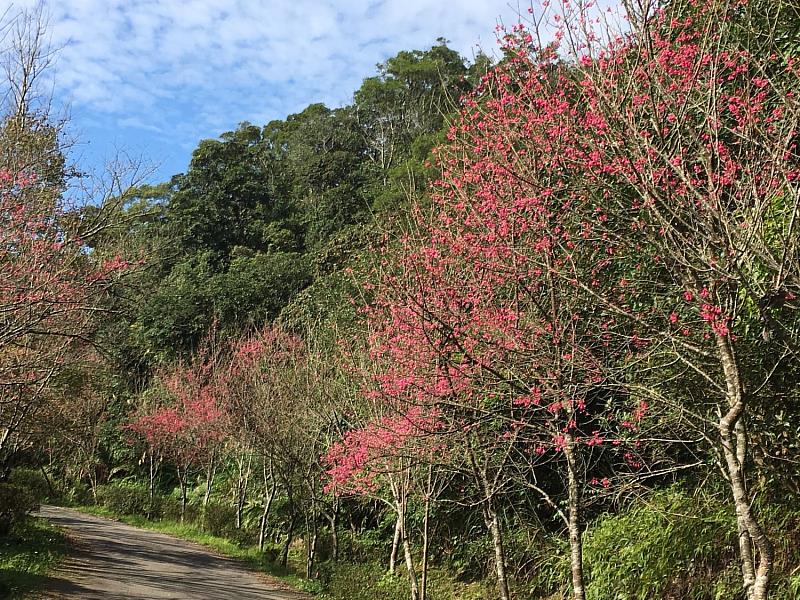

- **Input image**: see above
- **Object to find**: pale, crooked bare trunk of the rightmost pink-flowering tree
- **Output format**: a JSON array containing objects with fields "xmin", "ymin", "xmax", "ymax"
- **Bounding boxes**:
[{"xmin": 717, "ymin": 336, "xmax": 774, "ymax": 600}]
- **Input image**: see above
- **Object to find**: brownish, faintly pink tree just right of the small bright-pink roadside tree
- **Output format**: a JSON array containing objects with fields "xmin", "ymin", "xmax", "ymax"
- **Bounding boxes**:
[{"xmin": 225, "ymin": 324, "xmax": 336, "ymax": 578}]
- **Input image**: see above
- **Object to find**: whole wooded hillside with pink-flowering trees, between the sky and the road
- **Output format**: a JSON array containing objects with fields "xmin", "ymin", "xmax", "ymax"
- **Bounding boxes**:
[{"xmin": 0, "ymin": 0, "xmax": 800, "ymax": 600}]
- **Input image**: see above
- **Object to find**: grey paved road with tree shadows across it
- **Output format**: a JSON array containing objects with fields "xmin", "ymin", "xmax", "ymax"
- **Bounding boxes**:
[{"xmin": 40, "ymin": 506, "xmax": 307, "ymax": 600}]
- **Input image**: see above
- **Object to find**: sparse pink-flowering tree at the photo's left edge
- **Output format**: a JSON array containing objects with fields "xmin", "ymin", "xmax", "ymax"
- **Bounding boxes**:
[{"xmin": 0, "ymin": 7, "xmax": 129, "ymax": 471}]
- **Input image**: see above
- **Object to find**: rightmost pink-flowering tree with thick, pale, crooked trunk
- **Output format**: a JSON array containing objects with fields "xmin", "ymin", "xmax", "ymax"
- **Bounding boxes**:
[{"xmin": 424, "ymin": 2, "xmax": 800, "ymax": 600}]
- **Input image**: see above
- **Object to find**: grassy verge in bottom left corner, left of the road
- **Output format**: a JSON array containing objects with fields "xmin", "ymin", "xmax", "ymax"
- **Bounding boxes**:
[{"xmin": 0, "ymin": 517, "xmax": 67, "ymax": 598}]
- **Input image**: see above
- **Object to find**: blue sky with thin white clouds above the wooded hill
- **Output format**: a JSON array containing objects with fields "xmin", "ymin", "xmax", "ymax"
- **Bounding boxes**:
[{"xmin": 7, "ymin": 0, "xmax": 530, "ymax": 182}]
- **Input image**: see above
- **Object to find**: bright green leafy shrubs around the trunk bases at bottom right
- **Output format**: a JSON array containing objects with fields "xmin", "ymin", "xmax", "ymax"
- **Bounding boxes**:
[{"xmin": 507, "ymin": 487, "xmax": 800, "ymax": 600}]
